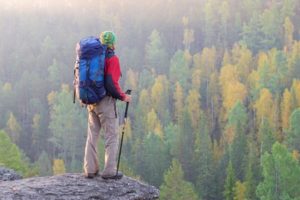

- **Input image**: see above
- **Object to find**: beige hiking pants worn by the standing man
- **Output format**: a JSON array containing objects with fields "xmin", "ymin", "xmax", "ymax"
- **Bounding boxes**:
[{"xmin": 84, "ymin": 96, "xmax": 119, "ymax": 175}]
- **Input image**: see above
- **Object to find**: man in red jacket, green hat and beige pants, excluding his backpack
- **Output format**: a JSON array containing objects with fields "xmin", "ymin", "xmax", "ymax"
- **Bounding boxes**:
[{"xmin": 84, "ymin": 31, "xmax": 131, "ymax": 179}]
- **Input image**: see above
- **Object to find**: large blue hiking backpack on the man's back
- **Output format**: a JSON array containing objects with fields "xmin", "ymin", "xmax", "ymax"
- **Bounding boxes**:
[{"xmin": 73, "ymin": 36, "xmax": 107, "ymax": 104}]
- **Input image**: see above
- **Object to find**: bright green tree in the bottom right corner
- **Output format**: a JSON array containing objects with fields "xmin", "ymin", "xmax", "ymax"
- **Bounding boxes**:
[{"xmin": 256, "ymin": 142, "xmax": 300, "ymax": 200}]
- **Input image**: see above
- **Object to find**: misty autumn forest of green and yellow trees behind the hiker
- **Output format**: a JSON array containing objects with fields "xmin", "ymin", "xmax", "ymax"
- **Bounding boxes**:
[{"xmin": 0, "ymin": 0, "xmax": 300, "ymax": 200}]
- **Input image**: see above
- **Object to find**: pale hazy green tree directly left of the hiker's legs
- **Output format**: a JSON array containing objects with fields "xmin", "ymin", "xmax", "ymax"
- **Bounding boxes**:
[{"xmin": 49, "ymin": 85, "xmax": 87, "ymax": 171}]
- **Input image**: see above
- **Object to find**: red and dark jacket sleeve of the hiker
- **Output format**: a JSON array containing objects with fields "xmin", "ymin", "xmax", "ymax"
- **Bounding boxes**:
[{"xmin": 104, "ymin": 55, "xmax": 126, "ymax": 101}]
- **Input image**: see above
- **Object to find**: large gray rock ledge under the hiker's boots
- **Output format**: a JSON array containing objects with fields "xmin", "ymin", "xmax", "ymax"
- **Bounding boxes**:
[{"xmin": 0, "ymin": 174, "xmax": 159, "ymax": 200}]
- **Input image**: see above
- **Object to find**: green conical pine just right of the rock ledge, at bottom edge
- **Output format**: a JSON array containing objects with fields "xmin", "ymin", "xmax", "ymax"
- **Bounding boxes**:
[{"xmin": 160, "ymin": 160, "xmax": 199, "ymax": 200}]
